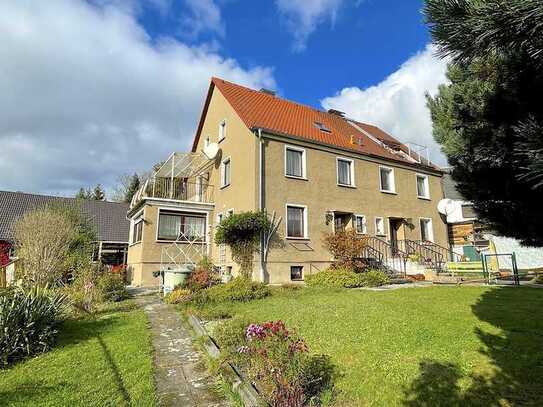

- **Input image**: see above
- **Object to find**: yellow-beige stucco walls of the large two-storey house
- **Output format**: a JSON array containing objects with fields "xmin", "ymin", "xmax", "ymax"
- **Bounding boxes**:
[{"xmin": 128, "ymin": 84, "xmax": 447, "ymax": 285}]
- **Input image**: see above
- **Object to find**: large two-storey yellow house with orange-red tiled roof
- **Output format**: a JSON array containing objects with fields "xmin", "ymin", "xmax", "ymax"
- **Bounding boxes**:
[{"xmin": 128, "ymin": 78, "xmax": 448, "ymax": 285}]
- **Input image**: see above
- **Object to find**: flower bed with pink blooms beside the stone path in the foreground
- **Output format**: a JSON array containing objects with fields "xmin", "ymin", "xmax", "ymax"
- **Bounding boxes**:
[{"xmin": 214, "ymin": 318, "xmax": 335, "ymax": 407}]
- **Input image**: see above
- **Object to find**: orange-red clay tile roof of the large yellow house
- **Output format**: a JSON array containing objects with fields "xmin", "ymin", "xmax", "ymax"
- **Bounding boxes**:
[{"xmin": 193, "ymin": 78, "xmax": 438, "ymax": 170}]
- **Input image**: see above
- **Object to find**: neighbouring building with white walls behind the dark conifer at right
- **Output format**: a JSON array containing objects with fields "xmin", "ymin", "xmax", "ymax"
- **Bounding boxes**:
[{"xmin": 439, "ymin": 171, "xmax": 543, "ymax": 269}]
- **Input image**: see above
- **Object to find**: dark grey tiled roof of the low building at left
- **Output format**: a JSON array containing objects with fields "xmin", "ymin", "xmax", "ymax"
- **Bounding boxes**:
[{"xmin": 0, "ymin": 191, "xmax": 130, "ymax": 242}]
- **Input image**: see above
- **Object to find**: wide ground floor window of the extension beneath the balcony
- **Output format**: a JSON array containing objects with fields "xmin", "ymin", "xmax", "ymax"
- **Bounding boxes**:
[{"xmin": 158, "ymin": 210, "xmax": 206, "ymax": 242}]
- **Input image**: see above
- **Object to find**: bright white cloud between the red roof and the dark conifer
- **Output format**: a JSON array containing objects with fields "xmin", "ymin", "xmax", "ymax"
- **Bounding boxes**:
[{"xmin": 321, "ymin": 45, "xmax": 447, "ymax": 165}]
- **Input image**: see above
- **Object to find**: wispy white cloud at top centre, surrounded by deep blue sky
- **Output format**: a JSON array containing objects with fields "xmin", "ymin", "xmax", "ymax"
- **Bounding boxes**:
[{"xmin": 275, "ymin": 0, "xmax": 343, "ymax": 52}]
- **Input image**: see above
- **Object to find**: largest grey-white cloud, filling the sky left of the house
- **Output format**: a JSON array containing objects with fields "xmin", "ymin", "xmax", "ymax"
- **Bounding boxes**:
[{"xmin": 0, "ymin": 0, "xmax": 275, "ymax": 198}]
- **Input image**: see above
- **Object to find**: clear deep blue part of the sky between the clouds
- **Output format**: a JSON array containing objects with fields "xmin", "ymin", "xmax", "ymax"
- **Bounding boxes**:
[{"xmin": 140, "ymin": 0, "xmax": 430, "ymax": 106}]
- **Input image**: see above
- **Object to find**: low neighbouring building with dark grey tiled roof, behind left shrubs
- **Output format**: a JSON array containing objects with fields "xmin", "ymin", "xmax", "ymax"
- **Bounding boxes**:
[{"xmin": 0, "ymin": 191, "xmax": 130, "ymax": 265}]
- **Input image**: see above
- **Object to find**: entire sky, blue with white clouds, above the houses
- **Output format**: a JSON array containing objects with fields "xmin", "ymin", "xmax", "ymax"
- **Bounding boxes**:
[{"xmin": 0, "ymin": 0, "xmax": 446, "ymax": 197}]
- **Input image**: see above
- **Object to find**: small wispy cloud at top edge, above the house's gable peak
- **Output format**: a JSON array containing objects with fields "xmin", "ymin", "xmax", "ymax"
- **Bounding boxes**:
[{"xmin": 182, "ymin": 0, "xmax": 225, "ymax": 38}]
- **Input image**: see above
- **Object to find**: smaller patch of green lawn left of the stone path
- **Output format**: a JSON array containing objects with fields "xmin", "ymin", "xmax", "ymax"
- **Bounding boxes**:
[{"xmin": 0, "ymin": 301, "xmax": 156, "ymax": 406}]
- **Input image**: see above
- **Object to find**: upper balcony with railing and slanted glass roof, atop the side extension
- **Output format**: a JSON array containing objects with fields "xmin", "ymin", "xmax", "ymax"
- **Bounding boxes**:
[{"xmin": 130, "ymin": 152, "xmax": 216, "ymax": 211}]
